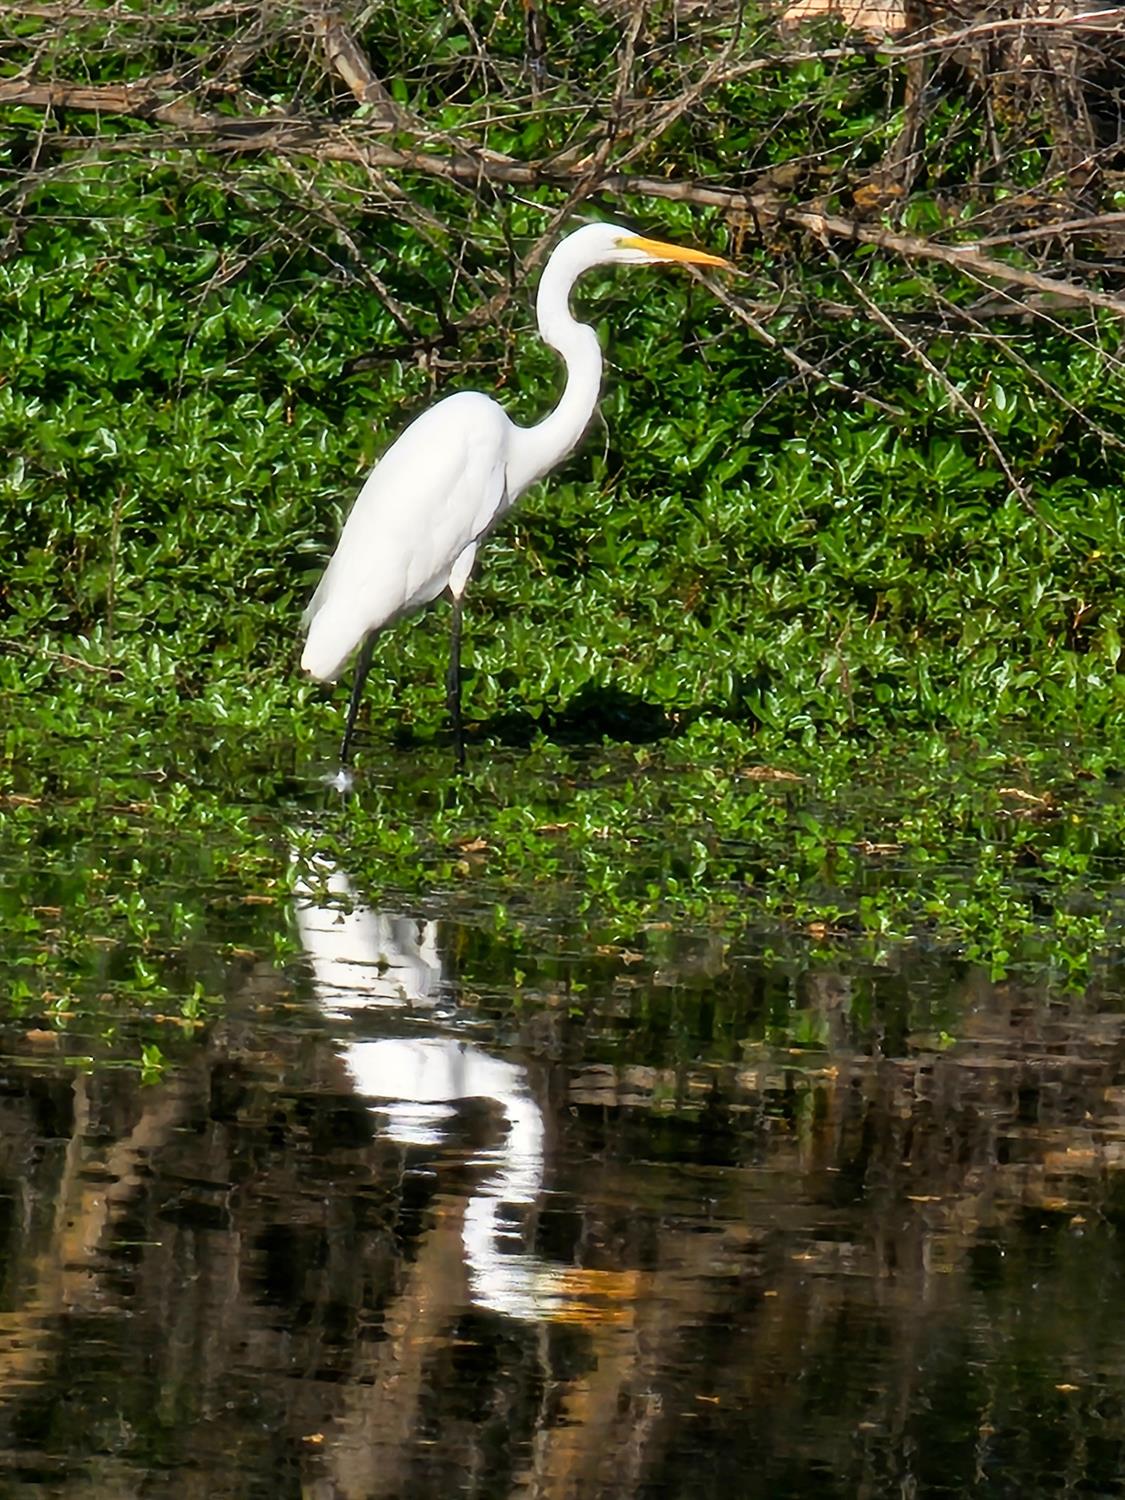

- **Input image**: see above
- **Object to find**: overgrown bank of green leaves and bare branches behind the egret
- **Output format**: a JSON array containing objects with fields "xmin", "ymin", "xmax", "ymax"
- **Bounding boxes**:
[{"xmin": 0, "ymin": 0, "xmax": 1125, "ymax": 984}]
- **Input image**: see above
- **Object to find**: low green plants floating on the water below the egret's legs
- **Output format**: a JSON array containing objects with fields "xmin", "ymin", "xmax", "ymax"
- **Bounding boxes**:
[{"xmin": 0, "ymin": 704, "xmax": 1125, "ymax": 1038}]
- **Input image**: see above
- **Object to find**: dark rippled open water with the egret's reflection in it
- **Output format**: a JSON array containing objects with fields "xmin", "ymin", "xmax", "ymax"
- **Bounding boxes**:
[{"xmin": 0, "ymin": 756, "xmax": 1125, "ymax": 1500}]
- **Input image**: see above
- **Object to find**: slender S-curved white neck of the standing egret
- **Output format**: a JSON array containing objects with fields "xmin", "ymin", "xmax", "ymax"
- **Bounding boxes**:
[{"xmin": 507, "ymin": 254, "xmax": 602, "ymax": 501}]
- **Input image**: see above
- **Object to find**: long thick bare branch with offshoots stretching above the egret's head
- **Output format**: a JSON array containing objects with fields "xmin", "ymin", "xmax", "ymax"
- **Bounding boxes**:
[{"xmin": 0, "ymin": 29, "xmax": 1125, "ymax": 334}]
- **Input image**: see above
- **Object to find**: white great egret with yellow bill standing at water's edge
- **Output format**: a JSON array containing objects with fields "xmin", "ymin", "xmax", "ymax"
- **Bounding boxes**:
[{"xmin": 302, "ymin": 224, "xmax": 734, "ymax": 767}]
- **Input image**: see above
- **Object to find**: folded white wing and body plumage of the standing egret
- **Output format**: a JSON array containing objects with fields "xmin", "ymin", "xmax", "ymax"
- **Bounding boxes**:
[{"xmin": 302, "ymin": 392, "xmax": 513, "ymax": 680}]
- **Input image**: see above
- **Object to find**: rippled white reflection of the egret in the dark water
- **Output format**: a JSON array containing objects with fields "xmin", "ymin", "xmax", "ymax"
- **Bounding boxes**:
[{"xmin": 297, "ymin": 863, "xmax": 569, "ymax": 1319}]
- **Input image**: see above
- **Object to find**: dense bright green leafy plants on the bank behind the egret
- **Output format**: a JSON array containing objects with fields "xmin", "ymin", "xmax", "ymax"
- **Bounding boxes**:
[{"xmin": 0, "ymin": 144, "xmax": 1125, "ymax": 737}]
